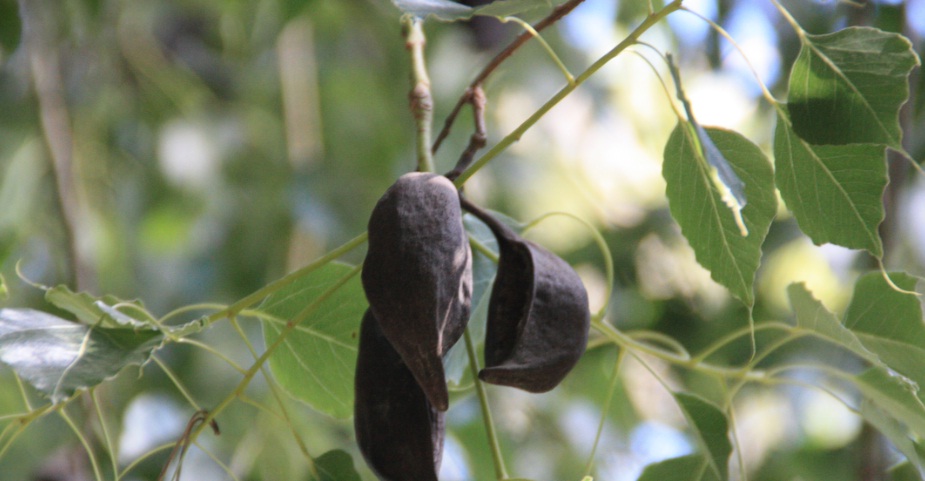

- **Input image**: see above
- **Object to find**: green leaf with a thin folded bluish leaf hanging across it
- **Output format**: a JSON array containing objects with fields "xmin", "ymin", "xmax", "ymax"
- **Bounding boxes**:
[{"xmin": 662, "ymin": 123, "xmax": 777, "ymax": 306}]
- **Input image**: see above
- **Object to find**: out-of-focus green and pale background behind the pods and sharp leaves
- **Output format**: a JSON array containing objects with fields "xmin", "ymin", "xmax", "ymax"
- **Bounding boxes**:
[{"xmin": 0, "ymin": 0, "xmax": 925, "ymax": 481}]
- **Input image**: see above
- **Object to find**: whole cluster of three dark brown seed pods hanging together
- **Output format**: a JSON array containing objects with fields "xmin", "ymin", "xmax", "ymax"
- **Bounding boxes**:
[{"xmin": 354, "ymin": 172, "xmax": 590, "ymax": 481}]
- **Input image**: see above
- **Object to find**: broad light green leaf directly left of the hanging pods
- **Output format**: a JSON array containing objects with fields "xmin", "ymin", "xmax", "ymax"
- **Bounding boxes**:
[{"xmin": 258, "ymin": 263, "xmax": 367, "ymax": 419}]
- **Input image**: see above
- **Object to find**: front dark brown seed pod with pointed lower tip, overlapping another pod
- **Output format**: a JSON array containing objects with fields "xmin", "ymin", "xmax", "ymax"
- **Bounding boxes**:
[{"xmin": 362, "ymin": 172, "xmax": 472, "ymax": 411}]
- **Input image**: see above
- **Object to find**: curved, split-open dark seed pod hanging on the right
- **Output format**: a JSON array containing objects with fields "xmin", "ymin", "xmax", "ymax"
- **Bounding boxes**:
[{"xmin": 463, "ymin": 200, "xmax": 591, "ymax": 392}]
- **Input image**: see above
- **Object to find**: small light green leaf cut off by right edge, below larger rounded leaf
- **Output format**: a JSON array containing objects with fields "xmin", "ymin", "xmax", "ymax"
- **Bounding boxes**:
[{"xmin": 854, "ymin": 367, "xmax": 925, "ymax": 437}]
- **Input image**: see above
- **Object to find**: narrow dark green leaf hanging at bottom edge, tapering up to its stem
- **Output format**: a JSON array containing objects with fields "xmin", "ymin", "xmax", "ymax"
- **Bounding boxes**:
[{"xmin": 674, "ymin": 393, "xmax": 732, "ymax": 480}]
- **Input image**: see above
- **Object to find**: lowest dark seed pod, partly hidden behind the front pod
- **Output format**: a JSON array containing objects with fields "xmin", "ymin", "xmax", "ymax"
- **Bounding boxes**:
[{"xmin": 353, "ymin": 309, "xmax": 444, "ymax": 481}]
